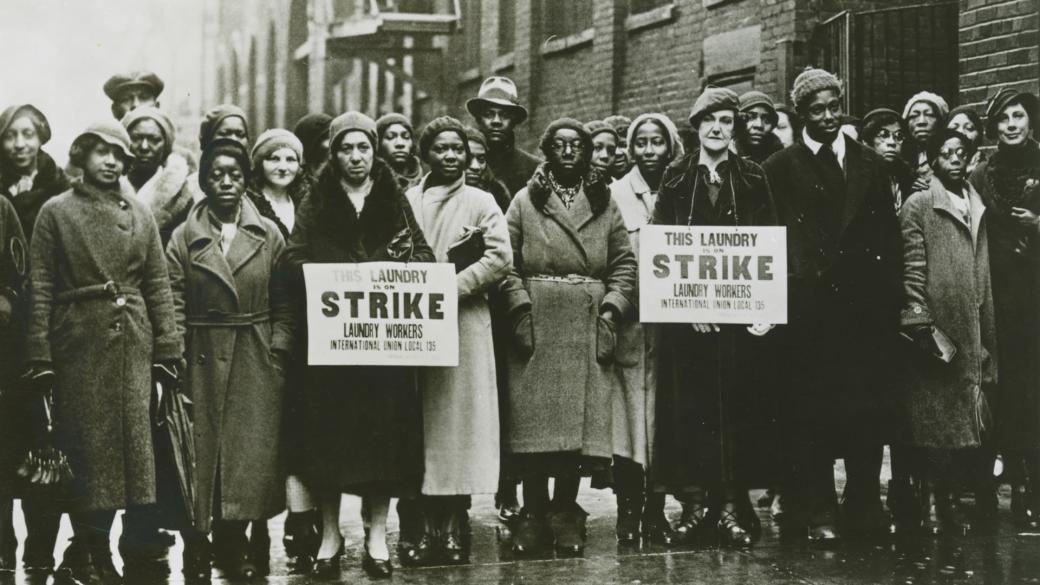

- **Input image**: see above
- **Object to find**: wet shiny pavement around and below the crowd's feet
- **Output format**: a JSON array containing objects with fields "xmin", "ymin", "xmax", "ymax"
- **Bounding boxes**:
[{"xmin": 6, "ymin": 468, "xmax": 1040, "ymax": 585}]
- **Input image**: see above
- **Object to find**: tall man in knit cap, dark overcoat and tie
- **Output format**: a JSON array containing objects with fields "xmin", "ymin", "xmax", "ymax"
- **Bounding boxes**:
[{"xmin": 763, "ymin": 68, "xmax": 902, "ymax": 541}]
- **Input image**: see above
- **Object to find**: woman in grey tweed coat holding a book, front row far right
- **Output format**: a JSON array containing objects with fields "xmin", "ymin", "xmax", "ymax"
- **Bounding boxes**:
[{"xmin": 900, "ymin": 129, "xmax": 997, "ymax": 531}]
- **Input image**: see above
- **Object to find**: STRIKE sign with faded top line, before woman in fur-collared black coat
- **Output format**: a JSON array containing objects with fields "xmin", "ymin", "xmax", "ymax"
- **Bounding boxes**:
[{"xmin": 304, "ymin": 262, "xmax": 459, "ymax": 366}]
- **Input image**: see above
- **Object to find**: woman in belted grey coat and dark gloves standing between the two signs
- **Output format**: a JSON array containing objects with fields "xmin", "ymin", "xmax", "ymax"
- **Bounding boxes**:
[{"xmin": 501, "ymin": 118, "xmax": 636, "ymax": 554}]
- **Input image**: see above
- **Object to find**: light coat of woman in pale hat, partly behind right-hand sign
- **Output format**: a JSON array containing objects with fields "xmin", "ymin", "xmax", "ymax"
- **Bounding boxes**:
[{"xmin": 610, "ymin": 167, "xmax": 657, "ymax": 465}]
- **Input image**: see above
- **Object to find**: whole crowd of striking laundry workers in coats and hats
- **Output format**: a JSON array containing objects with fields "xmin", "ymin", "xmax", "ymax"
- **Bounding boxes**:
[{"xmin": 0, "ymin": 68, "xmax": 1040, "ymax": 581}]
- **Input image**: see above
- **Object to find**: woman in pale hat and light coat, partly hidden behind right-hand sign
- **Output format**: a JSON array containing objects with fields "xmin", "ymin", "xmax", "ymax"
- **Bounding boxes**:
[{"xmin": 610, "ymin": 113, "xmax": 682, "ymax": 544}]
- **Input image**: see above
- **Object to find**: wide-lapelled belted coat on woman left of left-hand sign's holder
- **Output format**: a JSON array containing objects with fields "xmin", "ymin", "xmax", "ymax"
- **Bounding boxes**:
[{"xmin": 166, "ymin": 198, "xmax": 292, "ymax": 532}]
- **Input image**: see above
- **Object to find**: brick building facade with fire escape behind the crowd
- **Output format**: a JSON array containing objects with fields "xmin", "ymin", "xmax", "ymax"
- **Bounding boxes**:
[{"xmin": 204, "ymin": 0, "xmax": 1040, "ymax": 149}]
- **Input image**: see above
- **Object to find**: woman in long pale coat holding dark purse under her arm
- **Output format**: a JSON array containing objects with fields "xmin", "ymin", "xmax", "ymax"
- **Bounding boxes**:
[{"xmin": 408, "ymin": 117, "xmax": 513, "ymax": 563}]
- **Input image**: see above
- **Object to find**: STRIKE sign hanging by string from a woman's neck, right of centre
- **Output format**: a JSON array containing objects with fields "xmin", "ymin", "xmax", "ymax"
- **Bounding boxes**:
[{"xmin": 640, "ymin": 226, "xmax": 787, "ymax": 325}]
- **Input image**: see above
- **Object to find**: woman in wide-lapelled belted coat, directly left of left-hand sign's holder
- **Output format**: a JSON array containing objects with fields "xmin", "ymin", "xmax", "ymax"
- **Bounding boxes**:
[{"xmin": 166, "ymin": 138, "xmax": 292, "ymax": 578}]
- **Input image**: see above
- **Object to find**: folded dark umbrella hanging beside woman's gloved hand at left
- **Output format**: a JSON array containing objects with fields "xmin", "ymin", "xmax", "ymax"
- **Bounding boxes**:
[{"xmin": 153, "ymin": 381, "xmax": 196, "ymax": 526}]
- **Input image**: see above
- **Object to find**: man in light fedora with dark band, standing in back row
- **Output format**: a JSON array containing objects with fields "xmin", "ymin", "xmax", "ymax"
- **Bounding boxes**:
[{"xmin": 466, "ymin": 76, "xmax": 541, "ymax": 195}]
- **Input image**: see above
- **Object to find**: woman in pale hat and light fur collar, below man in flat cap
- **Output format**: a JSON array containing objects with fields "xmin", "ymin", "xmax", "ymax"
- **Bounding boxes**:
[{"xmin": 122, "ymin": 106, "xmax": 191, "ymax": 248}]
